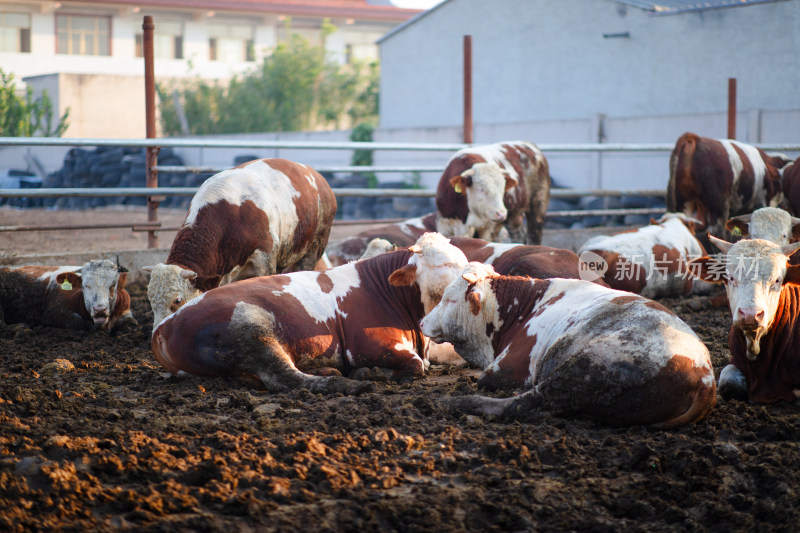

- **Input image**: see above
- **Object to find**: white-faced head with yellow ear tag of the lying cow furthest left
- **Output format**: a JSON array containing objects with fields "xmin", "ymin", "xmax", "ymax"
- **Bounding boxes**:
[{"xmin": 56, "ymin": 259, "xmax": 128, "ymax": 327}]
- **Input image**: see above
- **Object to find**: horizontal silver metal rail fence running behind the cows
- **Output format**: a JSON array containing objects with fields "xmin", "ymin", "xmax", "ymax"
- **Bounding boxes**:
[{"xmin": 0, "ymin": 137, "xmax": 800, "ymax": 247}]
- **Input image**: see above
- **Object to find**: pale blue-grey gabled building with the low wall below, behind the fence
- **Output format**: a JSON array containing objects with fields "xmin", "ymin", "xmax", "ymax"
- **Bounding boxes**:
[{"xmin": 379, "ymin": 0, "xmax": 800, "ymax": 188}]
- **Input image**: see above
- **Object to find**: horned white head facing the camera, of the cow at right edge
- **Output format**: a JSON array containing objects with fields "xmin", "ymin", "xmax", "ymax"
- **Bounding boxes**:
[{"xmin": 689, "ymin": 235, "xmax": 800, "ymax": 361}]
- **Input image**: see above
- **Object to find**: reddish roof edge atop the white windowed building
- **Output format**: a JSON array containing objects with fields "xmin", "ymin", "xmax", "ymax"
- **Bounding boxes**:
[{"xmin": 61, "ymin": 0, "xmax": 422, "ymax": 22}]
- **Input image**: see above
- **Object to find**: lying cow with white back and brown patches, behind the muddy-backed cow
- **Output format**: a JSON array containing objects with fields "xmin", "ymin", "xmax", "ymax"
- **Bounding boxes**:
[{"xmin": 578, "ymin": 213, "xmax": 707, "ymax": 298}]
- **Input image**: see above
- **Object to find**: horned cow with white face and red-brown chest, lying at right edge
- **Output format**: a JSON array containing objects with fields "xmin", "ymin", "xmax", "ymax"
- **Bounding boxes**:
[{"xmin": 690, "ymin": 236, "xmax": 800, "ymax": 404}]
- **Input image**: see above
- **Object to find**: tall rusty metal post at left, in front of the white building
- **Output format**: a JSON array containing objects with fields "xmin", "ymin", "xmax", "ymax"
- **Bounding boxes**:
[{"xmin": 142, "ymin": 15, "xmax": 159, "ymax": 248}]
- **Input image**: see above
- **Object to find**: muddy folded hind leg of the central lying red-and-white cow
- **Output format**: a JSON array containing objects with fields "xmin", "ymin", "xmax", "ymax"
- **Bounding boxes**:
[{"xmin": 252, "ymin": 338, "xmax": 372, "ymax": 394}]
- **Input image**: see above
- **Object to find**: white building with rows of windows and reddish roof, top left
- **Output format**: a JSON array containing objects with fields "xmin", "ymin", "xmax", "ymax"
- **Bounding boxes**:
[{"xmin": 0, "ymin": 0, "xmax": 420, "ymax": 138}]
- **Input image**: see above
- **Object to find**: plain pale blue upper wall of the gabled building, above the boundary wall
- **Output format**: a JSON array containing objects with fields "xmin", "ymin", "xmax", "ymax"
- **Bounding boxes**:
[{"xmin": 380, "ymin": 0, "xmax": 800, "ymax": 130}]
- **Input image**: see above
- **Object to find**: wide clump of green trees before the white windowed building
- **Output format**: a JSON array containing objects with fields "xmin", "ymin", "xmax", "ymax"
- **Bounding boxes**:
[{"xmin": 158, "ymin": 25, "xmax": 378, "ymax": 135}]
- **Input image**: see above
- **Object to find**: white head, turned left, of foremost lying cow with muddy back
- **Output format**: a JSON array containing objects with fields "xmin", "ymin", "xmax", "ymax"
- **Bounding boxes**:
[{"xmin": 420, "ymin": 262, "xmax": 499, "ymax": 368}]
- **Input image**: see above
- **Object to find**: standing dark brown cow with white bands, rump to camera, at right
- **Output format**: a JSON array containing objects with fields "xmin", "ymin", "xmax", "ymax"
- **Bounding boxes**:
[{"xmin": 667, "ymin": 133, "xmax": 789, "ymax": 244}]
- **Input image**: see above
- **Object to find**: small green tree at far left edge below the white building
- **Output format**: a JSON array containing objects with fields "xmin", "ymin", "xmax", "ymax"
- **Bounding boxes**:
[{"xmin": 0, "ymin": 68, "xmax": 69, "ymax": 137}]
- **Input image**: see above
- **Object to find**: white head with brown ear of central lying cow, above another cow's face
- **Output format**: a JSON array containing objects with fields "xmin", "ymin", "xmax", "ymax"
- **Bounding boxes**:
[{"xmin": 389, "ymin": 233, "xmax": 467, "ymax": 313}]
